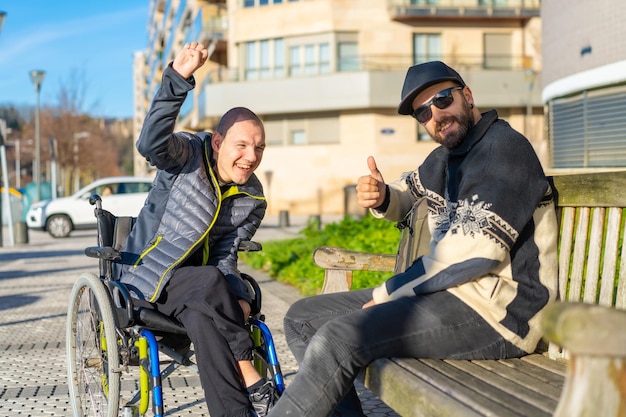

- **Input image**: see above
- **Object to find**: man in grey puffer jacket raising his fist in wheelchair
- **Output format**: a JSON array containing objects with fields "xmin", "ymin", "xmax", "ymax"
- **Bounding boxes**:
[{"xmin": 114, "ymin": 42, "xmax": 277, "ymax": 417}]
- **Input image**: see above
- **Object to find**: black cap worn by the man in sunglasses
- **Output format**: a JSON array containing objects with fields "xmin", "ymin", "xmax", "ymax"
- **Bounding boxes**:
[{"xmin": 398, "ymin": 61, "xmax": 465, "ymax": 114}]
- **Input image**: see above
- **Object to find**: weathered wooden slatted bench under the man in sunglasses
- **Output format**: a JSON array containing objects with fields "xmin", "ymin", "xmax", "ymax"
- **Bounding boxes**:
[{"xmin": 313, "ymin": 172, "xmax": 626, "ymax": 417}]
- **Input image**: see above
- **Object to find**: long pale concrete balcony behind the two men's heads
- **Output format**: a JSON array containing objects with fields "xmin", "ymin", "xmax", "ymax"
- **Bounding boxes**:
[{"xmin": 198, "ymin": 52, "xmax": 542, "ymax": 120}]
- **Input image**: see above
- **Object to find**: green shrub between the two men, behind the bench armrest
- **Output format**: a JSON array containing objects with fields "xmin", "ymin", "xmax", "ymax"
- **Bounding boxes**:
[{"xmin": 240, "ymin": 215, "xmax": 400, "ymax": 295}]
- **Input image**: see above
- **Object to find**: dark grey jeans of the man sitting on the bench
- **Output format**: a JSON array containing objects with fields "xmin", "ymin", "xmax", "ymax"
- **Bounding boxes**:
[{"xmin": 270, "ymin": 289, "xmax": 525, "ymax": 417}]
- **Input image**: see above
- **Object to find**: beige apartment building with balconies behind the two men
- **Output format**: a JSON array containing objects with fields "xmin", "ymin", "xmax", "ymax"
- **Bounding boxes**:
[{"xmin": 135, "ymin": 0, "xmax": 549, "ymax": 215}]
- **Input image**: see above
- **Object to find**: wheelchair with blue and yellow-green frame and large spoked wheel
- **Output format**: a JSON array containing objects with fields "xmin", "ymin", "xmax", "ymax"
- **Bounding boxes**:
[{"xmin": 67, "ymin": 195, "xmax": 285, "ymax": 417}]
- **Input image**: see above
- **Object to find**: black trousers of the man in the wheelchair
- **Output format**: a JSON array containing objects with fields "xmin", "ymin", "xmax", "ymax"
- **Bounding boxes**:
[{"xmin": 155, "ymin": 266, "xmax": 253, "ymax": 417}]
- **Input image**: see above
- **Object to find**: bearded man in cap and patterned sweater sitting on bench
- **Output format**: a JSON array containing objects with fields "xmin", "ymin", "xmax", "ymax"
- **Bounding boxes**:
[{"xmin": 270, "ymin": 61, "xmax": 557, "ymax": 417}]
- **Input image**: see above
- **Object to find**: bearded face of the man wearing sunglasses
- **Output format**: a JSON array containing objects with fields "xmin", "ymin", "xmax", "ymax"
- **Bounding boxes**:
[{"xmin": 413, "ymin": 81, "xmax": 480, "ymax": 149}]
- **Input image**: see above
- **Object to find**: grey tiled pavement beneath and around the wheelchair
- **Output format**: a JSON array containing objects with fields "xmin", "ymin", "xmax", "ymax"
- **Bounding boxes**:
[{"xmin": 0, "ymin": 216, "xmax": 397, "ymax": 417}]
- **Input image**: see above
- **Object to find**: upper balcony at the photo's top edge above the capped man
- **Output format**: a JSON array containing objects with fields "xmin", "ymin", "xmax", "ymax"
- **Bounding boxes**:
[{"xmin": 388, "ymin": 0, "xmax": 541, "ymax": 23}]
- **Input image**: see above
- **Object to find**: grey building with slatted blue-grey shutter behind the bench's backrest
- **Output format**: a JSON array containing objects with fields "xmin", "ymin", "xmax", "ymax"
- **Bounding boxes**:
[{"xmin": 541, "ymin": 0, "xmax": 626, "ymax": 170}]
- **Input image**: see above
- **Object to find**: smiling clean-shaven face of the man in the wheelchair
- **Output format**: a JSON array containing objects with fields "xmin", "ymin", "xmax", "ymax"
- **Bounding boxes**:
[{"xmin": 211, "ymin": 119, "xmax": 265, "ymax": 184}]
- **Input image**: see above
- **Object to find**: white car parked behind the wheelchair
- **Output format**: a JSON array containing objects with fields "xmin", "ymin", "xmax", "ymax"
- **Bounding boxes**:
[{"xmin": 26, "ymin": 177, "xmax": 152, "ymax": 237}]
